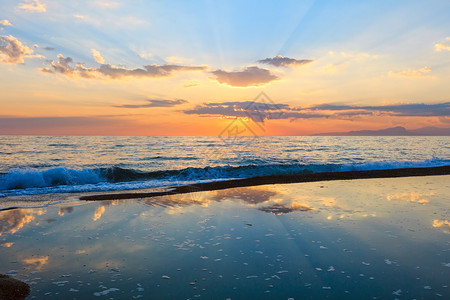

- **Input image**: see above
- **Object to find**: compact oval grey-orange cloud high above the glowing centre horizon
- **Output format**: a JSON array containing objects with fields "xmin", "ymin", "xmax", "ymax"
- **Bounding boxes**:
[{"xmin": 211, "ymin": 67, "xmax": 278, "ymax": 87}]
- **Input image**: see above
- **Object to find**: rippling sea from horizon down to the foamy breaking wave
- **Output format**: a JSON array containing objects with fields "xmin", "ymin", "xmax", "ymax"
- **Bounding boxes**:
[{"xmin": 0, "ymin": 136, "xmax": 450, "ymax": 201}]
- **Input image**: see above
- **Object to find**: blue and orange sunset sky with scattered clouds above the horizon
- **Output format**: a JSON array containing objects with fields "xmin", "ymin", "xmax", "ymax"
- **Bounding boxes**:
[{"xmin": 0, "ymin": 0, "xmax": 450, "ymax": 136}]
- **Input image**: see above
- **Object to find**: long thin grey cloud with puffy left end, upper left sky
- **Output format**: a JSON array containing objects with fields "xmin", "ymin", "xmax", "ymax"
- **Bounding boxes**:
[{"xmin": 41, "ymin": 54, "xmax": 207, "ymax": 79}]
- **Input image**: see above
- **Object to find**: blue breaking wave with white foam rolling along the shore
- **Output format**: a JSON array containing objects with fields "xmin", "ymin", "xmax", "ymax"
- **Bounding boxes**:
[{"xmin": 0, "ymin": 158, "xmax": 449, "ymax": 197}]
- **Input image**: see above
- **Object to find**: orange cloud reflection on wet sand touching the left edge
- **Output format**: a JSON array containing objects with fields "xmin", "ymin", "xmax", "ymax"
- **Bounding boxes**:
[{"xmin": 0, "ymin": 209, "xmax": 46, "ymax": 235}]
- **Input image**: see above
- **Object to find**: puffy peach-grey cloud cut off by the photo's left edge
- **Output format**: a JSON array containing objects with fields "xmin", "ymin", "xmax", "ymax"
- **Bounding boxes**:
[{"xmin": 0, "ymin": 35, "xmax": 33, "ymax": 64}]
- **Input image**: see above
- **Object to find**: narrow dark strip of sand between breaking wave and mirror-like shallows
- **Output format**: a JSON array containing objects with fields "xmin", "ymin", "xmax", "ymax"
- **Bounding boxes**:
[{"xmin": 79, "ymin": 166, "xmax": 450, "ymax": 201}]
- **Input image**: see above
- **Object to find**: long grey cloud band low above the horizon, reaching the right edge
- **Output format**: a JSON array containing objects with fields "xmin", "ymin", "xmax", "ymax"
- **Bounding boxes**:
[{"xmin": 184, "ymin": 101, "xmax": 450, "ymax": 122}]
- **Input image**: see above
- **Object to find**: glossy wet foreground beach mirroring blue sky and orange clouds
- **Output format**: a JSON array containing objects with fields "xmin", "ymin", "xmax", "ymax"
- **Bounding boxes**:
[{"xmin": 0, "ymin": 175, "xmax": 450, "ymax": 299}]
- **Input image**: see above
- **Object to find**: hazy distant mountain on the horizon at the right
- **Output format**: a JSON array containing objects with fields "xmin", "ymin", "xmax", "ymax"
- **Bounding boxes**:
[{"xmin": 313, "ymin": 126, "xmax": 450, "ymax": 136}]
